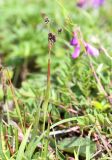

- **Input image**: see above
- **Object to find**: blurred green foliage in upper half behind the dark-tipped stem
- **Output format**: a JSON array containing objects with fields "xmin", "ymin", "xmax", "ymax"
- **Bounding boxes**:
[{"xmin": 0, "ymin": 0, "xmax": 112, "ymax": 87}]
